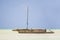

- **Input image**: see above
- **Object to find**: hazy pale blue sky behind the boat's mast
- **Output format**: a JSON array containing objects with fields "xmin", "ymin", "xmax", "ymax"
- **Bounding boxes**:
[{"xmin": 0, "ymin": 0, "xmax": 60, "ymax": 29}]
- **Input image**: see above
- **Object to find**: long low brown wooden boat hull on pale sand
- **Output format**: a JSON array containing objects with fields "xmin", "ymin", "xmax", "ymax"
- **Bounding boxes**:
[{"xmin": 13, "ymin": 29, "xmax": 54, "ymax": 34}]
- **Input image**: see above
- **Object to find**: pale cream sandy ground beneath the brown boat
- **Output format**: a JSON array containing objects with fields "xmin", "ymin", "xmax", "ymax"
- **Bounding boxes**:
[{"xmin": 0, "ymin": 30, "xmax": 60, "ymax": 40}]
